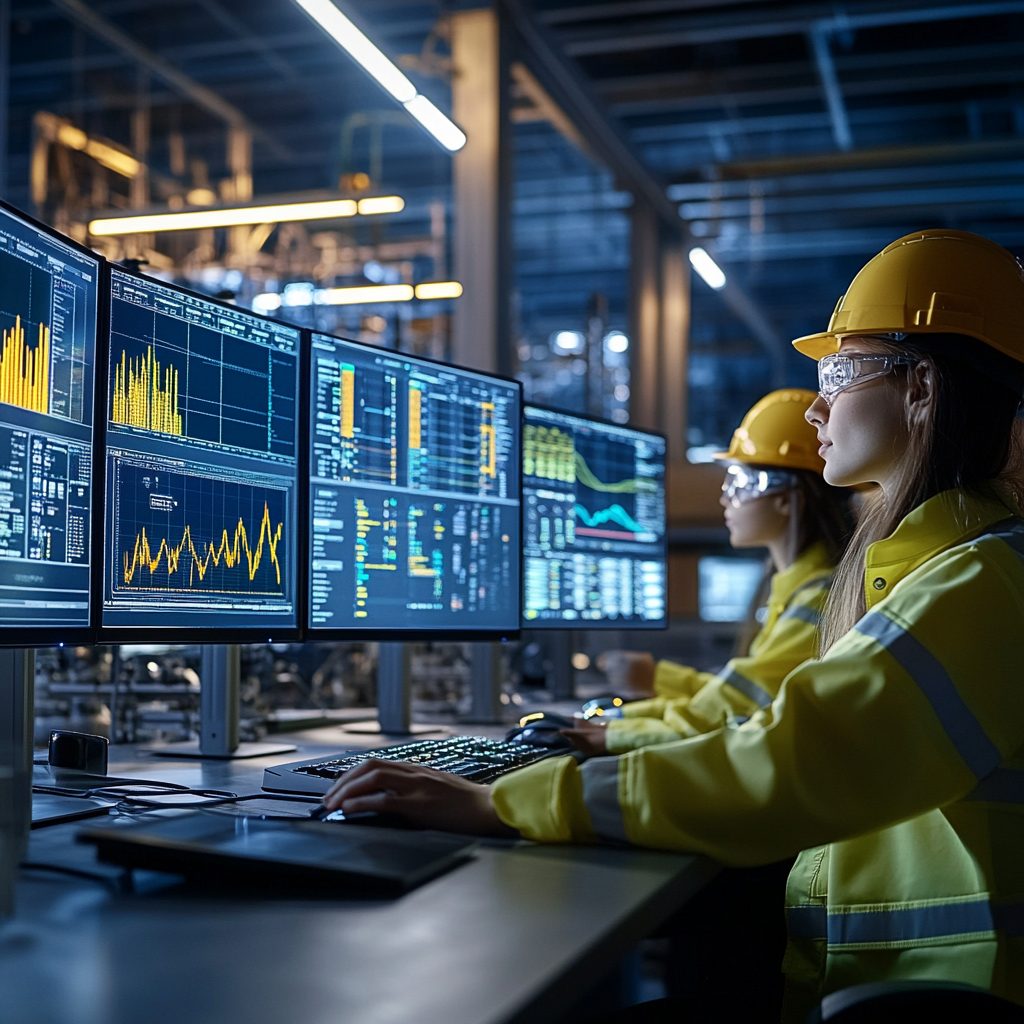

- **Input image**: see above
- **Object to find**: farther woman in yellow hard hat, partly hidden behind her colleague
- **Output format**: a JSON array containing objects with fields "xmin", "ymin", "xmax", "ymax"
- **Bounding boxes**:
[{"xmin": 564, "ymin": 388, "xmax": 849, "ymax": 755}]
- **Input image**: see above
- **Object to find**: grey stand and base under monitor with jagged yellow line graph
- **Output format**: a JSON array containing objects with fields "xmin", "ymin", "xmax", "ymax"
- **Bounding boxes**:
[{"xmin": 145, "ymin": 644, "xmax": 298, "ymax": 761}]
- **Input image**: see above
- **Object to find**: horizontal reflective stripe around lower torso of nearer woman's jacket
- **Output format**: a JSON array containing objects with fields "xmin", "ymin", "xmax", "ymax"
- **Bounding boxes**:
[{"xmin": 827, "ymin": 898, "xmax": 995, "ymax": 946}]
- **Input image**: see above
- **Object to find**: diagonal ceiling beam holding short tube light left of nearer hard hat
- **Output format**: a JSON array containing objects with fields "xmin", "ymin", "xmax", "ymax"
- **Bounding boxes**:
[{"xmin": 500, "ymin": 0, "xmax": 783, "ymax": 362}]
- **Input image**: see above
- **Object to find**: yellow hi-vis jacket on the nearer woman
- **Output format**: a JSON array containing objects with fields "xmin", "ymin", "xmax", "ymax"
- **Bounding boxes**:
[{"xmin": 492, "ymin": 484, "xmax": 1024, "ymax": 1021}]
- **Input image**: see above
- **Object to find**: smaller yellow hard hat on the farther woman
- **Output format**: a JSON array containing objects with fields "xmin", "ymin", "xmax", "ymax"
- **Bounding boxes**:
[{"xmin": 715, "ymin": 387, "xmax": 825, "ymax": 473}]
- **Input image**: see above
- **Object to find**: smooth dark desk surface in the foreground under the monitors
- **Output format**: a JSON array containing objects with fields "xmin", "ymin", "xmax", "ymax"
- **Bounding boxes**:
[{"xmin": 0, "ymin": 729, "xmax": 716, "ymax": 1024}]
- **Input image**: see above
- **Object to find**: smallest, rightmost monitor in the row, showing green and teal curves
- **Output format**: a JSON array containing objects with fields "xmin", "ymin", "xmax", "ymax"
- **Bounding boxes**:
[{"xmin": 522, "ymin": 406, "xmax": 668, "ymax": 630}]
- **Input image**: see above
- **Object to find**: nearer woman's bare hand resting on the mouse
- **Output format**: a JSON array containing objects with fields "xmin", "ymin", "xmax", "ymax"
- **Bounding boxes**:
[{"xmin": 324, "ymin": 758, "xmax": 519, "ymax": 839}]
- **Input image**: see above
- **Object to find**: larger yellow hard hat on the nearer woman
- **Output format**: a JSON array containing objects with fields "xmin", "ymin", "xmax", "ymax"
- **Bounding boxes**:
[{"xmin": 793, "ymin": 228, "xmax": 1024, "ymax": 362}]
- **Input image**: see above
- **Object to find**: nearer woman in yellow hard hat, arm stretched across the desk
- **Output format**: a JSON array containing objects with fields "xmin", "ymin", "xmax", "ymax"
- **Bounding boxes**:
[{"xmin": 326, "ymin": 230, "xmax": 1024, "ymax": 1022}]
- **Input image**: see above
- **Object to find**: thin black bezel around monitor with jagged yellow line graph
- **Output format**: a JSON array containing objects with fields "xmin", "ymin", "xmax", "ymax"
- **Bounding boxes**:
[{"xmin": 92, "ymin": 262, "xmax": 309, "ymax": 644}]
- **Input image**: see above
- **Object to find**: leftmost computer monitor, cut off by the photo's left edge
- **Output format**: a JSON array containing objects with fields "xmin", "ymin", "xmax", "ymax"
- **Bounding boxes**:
[{"xmin": 0, "ymin": 205, "xmax": 102, "ymax": 646}]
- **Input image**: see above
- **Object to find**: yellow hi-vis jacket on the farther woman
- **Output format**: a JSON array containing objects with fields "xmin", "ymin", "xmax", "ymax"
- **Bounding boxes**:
[{"xmin": 605, "ymin": 543, "xmax": 834, "ymax": 754}]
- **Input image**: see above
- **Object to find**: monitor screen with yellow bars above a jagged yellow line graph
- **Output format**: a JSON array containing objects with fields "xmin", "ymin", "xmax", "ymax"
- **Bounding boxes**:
[{"xmin": 100, "ymin": 268, "xmax": 302, "ymax": 643}]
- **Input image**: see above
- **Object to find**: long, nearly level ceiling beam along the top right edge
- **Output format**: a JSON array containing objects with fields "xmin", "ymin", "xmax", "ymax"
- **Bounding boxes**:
[{"xmin": 563, "ymin": 0, "xmax": 1024, "ymax": 57}]
